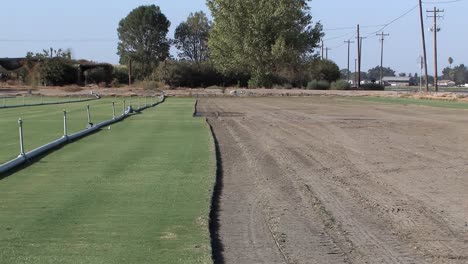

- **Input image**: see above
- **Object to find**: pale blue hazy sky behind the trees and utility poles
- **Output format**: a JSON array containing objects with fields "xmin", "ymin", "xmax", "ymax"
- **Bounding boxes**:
[{"xmin": 0, "ymin": 0, "xmax": 468, "ymax": 75}]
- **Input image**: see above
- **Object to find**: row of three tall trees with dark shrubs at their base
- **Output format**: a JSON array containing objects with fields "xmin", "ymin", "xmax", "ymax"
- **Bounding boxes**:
[{"xmin": 117, "ymin": 0, "xmax": 340, "ymax": 88}]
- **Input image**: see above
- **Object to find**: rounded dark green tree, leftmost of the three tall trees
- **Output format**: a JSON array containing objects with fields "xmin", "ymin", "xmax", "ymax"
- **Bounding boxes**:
[{"xmin": 117, "ymin": 5, "xmax": 171, "ymax": 79}]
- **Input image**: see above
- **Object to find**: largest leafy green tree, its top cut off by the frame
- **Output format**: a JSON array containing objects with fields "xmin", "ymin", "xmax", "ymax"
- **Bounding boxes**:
[{"xmin": 207, "ymin": 0, "xmax": 323, "ymax": 86}]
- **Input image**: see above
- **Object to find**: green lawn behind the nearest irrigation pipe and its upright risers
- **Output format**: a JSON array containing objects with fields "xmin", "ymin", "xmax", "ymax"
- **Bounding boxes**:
[{"xmin": 0, "ymin": 98, "xmax": 133, "ymax": 163}]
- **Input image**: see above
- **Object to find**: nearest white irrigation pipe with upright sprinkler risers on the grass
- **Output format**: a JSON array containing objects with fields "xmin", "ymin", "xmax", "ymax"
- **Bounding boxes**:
[{"xmin": 0, "ymin": 95, "xmax": 166, "ymax": 175}]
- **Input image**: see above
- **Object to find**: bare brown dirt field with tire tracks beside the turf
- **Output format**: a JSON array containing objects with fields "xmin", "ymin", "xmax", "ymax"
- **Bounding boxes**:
[{"xmin": 197, "ymin": 96, "xmax": 468, "ymax": 264}]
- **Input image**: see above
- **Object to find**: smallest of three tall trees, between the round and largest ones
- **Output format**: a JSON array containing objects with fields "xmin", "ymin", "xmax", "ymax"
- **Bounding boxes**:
[{"xmin": 174, "ymin": 12, "xmax": 211, "ymax": 63}]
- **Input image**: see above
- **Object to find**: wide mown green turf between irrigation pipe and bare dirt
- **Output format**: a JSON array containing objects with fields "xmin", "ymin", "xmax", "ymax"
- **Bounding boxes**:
[{"xmin": 0, "ymin": 99, "xmax": 216, "ymax": 263}]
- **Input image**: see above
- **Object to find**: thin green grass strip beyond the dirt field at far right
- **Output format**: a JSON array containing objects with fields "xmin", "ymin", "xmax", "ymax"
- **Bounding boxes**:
[{"xmin": 349, "ymin": 97, "xmax": 468, "ymax": 109}]
